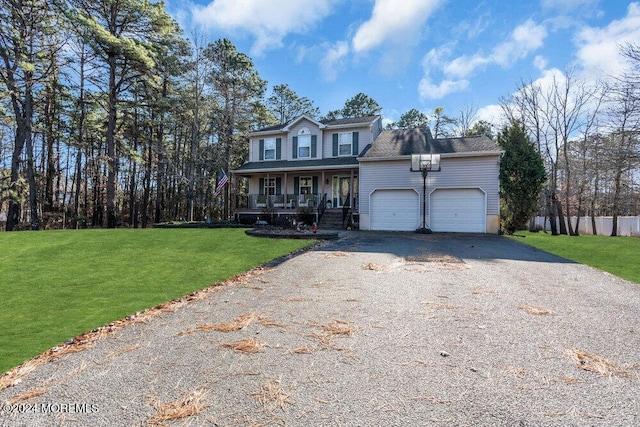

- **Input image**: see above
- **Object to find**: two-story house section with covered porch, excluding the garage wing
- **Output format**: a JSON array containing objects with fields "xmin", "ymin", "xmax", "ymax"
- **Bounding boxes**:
[{"xmin": 232, "ymin": 115, "xmax": 382, "ymax": 226}]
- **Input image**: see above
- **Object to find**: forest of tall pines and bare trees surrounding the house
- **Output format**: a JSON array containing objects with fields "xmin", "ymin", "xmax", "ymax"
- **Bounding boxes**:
[{"xmin": 0, "ymin": 0, "xmax": 640, "ymax": 233}]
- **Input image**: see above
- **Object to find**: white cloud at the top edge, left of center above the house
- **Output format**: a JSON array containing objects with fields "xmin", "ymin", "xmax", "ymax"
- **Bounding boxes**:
[{"xmin": 192, "ymin": 0, "xmax": 337, "ymax": 55}]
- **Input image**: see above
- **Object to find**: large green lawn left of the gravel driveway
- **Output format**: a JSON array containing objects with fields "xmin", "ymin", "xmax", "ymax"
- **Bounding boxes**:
[{"xmin": 0, "ymin": 229, "xmax": 311, "ymax": 373}]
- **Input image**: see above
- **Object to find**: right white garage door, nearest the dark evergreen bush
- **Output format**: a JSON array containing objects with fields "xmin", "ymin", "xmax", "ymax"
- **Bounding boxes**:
[{"xmin": 429, "ymin": 188, "xmax": 486, "ymax": 233}]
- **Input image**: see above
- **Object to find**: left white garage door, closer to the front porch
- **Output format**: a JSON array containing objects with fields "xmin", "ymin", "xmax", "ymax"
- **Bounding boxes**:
[{"xmin": 370, "ymin": 190, "xmax": 420, "ymax": 231}]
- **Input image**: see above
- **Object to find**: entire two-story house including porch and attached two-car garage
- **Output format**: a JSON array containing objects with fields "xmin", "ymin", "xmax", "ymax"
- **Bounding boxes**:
[{"xmin": 232, "ymin": 116, "xmax": 502, "ymax": 233}]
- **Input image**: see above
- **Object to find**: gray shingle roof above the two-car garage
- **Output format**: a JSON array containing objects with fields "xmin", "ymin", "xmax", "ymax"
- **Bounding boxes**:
[{"xmin": 362, "ymin": 128, "xmax": 501, "ymax": 159}]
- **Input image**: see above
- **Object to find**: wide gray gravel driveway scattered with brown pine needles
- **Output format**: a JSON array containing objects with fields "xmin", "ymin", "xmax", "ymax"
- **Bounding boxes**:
[{"xmin": 0, "ymin": 232, "xmax": 640, "ymax": 426}]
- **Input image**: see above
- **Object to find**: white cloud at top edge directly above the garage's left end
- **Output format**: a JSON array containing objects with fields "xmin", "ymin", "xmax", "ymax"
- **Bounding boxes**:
[{"xmin": 352, "ymin": 0, "xmax": 444, "ymax": 53}]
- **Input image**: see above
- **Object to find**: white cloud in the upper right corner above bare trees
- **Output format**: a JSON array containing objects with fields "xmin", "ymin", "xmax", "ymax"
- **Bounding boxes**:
[{"xmin": 576, "ymin": 3, "xmax": 640, "ymax": 77}]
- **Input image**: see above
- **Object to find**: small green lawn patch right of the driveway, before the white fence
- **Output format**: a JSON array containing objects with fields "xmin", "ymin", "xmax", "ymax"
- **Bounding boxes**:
[{"xmin": 514, "ymin": 232, "xmax": 640, "ymax": 283}]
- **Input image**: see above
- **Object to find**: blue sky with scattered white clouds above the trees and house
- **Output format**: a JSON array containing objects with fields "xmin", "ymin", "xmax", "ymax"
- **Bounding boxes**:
[{"xmin": 167, "ymin": 0, "xmax": 640, "ymax": 124}]
